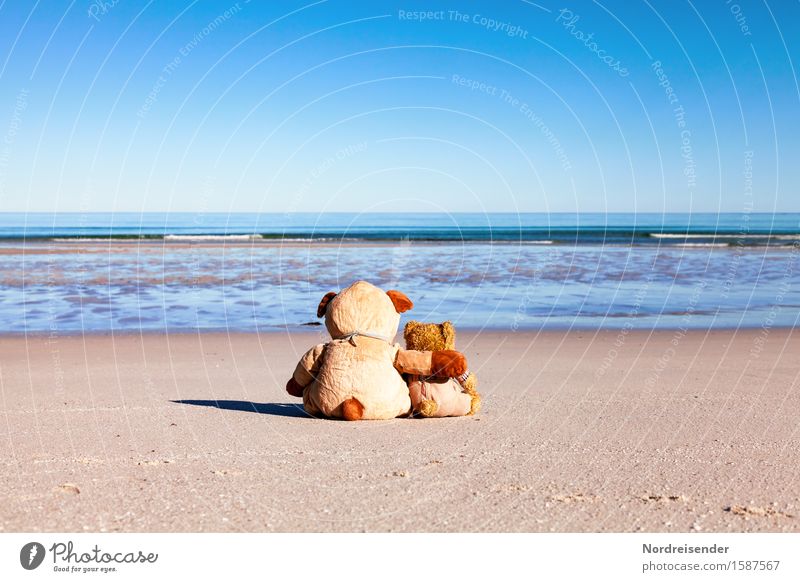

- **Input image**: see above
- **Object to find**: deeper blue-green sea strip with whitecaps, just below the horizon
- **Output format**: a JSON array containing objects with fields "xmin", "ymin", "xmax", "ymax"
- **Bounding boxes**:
[{"xmin": 0, "ymin": 212, "xmax": 800, "ymax": 247}]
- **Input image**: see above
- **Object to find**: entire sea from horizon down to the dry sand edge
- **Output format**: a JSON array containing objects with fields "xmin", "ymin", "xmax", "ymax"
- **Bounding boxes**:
[{"xmin": 0, "ymin": 214, "xmax": 800, "ymax": 334}]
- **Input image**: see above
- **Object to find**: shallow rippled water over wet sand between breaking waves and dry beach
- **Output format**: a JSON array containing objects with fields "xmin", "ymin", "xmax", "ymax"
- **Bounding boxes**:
[{"xmin": 0, "ymin": 235, "xmax": 800, "ymax": 333}]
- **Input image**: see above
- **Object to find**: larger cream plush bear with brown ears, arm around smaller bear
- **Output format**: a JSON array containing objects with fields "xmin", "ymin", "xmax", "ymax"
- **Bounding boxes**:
[{"xmin": 286, "ymin": 281, "xmax": 467, "ymax": 420}]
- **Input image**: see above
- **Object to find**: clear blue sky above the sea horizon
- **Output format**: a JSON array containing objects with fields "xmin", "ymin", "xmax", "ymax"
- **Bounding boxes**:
[{"xmin": 0, "ymin": 0, "xmax": 800, "ymax": 212}]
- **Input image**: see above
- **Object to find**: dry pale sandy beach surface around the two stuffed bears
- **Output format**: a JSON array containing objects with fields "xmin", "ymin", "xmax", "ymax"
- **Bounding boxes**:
[{"xmin": 0, "ymin": 329, "xmax": 800, "ymax": 532}]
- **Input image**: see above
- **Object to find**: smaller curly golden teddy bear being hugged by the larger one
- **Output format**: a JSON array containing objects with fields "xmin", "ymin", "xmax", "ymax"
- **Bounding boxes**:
[{"xmin": 403, "ymin": 321, "xmax": 481, "ymax": 417}]
